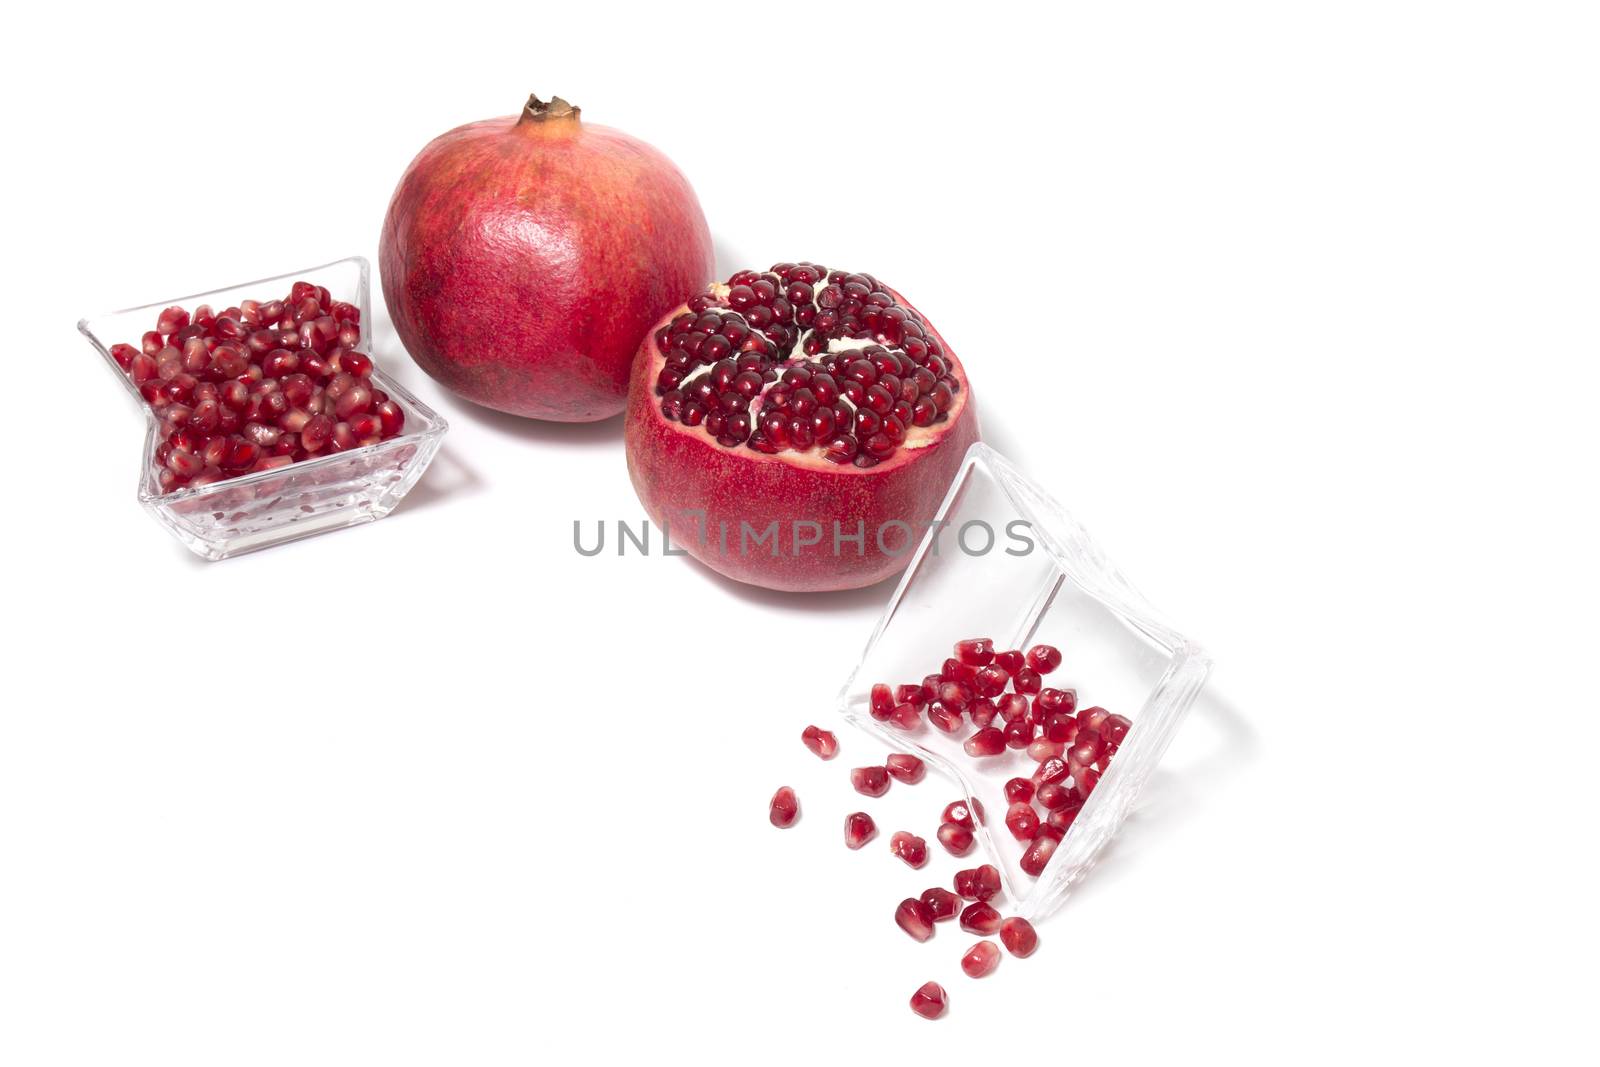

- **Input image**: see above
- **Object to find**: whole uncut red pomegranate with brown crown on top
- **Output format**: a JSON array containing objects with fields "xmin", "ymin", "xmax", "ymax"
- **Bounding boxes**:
[{"xmin": 378, "ymin": 96, "xmax": 712, "ymax": 422}]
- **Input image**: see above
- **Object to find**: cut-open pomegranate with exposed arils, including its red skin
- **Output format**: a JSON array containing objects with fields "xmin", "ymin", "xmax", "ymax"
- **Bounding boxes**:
[{"xmin": 624, "ymin": 262, "xmax": 978, "ymax": 590}]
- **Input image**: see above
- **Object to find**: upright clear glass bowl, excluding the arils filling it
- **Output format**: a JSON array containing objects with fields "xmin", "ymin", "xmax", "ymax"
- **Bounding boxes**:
[{"xmin": 78, "ymin": 256, "xmax": 450, "ymax": 560}]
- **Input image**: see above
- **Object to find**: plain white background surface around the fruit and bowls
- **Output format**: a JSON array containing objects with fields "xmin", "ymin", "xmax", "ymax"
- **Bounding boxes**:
[{"xmin": 0, "ymin": 3, "xmax": 1600, "ymax": 1067}]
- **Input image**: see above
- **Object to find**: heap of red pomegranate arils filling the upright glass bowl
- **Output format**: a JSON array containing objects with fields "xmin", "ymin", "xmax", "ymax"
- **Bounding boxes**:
[{"xmin": 110, "ymin": 282, "xmax": 405, "ymax": 493}]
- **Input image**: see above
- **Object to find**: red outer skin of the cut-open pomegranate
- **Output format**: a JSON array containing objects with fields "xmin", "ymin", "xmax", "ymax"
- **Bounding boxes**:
[{"xmin": 622, "ymin": 290, "xmax": 979, "ymax": 592}]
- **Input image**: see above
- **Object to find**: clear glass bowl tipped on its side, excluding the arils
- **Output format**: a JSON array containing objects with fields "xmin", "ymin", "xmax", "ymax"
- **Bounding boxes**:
[{"xmin": 840, "ymin": 443, "xmax": 1211, "ymax": 918}]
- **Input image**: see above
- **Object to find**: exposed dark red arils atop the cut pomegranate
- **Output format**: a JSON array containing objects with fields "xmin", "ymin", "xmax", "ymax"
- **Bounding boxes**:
[{"xmin": 656, "ymin": 262, "xmax": 962, "ymax": 467}]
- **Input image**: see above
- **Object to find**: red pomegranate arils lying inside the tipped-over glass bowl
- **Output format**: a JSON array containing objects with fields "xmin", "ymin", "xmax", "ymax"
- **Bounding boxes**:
[{"xmin": 867, "ymin": 637, "xmax": 1133, "ymax": 878}]
